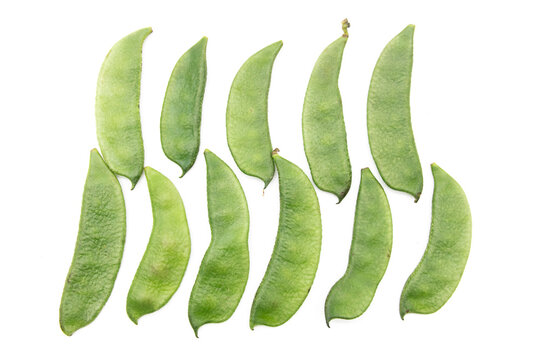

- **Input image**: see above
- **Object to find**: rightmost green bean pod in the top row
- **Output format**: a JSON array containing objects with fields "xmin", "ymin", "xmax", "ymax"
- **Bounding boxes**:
[{"xmin": 367, "ymin": 25, "xmax": 423, "ymax": 202}]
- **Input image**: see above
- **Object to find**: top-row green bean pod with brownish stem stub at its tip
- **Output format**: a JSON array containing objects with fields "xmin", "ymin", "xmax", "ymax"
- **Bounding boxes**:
[{"xmin": 302, "ymin": 20, "xmax": 352, "ymax": 202}]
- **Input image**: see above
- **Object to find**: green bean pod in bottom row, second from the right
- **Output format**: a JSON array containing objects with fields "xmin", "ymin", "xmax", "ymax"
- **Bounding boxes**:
[{"xmin": 325, "ymin": 168, "xmax": 392, "ymax": 327}]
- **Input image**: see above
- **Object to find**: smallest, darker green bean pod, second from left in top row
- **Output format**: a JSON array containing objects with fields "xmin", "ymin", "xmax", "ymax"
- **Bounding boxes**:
[{"xmin": 161, "ymin": 37, "xmax": 208, "ymax": 176}]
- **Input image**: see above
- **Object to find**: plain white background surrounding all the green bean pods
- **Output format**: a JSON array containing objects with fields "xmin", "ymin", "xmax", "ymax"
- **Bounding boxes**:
[{"xmin": 0, "ymin": 0, "xmax": 540, "ymax": 359}]
